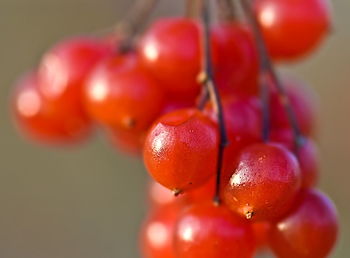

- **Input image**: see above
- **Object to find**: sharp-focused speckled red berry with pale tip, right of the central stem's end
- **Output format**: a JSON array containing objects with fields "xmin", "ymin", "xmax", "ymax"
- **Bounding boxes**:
[{"xmin": 222, "ymin": 143, "xmax": 301, "ymax": 220}]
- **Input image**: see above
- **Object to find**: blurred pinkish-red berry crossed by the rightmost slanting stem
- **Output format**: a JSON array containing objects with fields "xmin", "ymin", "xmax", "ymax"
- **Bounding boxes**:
[{"xmin": 270, "ymin": 77, "xmax": 317, "ymax": 136}]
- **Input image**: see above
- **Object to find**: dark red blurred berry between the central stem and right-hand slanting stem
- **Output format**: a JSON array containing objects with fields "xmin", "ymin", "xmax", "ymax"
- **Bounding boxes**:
[{"xmin": 213, "ymin": 23, "xmax": 259, "ymax": 94}]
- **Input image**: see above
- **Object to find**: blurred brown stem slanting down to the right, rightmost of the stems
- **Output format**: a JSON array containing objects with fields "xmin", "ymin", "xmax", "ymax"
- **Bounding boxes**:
[{"xmin": 240, "ymin": 0, "xmax": 303, "ymax": 149}]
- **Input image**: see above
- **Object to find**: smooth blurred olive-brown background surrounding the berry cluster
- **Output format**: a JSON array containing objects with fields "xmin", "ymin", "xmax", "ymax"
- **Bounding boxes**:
[{"xmin": 0, "ymin": 0, "xmax": 350, "ymax": 258}]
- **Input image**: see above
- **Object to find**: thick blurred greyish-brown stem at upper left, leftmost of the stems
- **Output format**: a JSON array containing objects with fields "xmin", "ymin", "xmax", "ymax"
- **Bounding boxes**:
[{"xmin": 117, "ymin": 0, "xmax": 159, "ymax": 53}]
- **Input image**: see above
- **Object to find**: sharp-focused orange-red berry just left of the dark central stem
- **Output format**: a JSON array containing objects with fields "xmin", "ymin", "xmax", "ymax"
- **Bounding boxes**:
[{"xmin": 144, "ymin": 109, "xmax": 219, "ymax": 193}]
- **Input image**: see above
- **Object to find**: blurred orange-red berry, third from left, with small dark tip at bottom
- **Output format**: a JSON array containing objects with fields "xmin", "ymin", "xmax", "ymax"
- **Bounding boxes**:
[{"xmin": 85, "ymin": 54, "xmax": 164, "ymax": 132}]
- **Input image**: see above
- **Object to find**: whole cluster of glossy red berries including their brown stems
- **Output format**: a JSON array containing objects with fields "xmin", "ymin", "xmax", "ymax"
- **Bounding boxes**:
[{"xmin": 13, "ymin": 0, "xmax": 338, "ymax": 258}]
